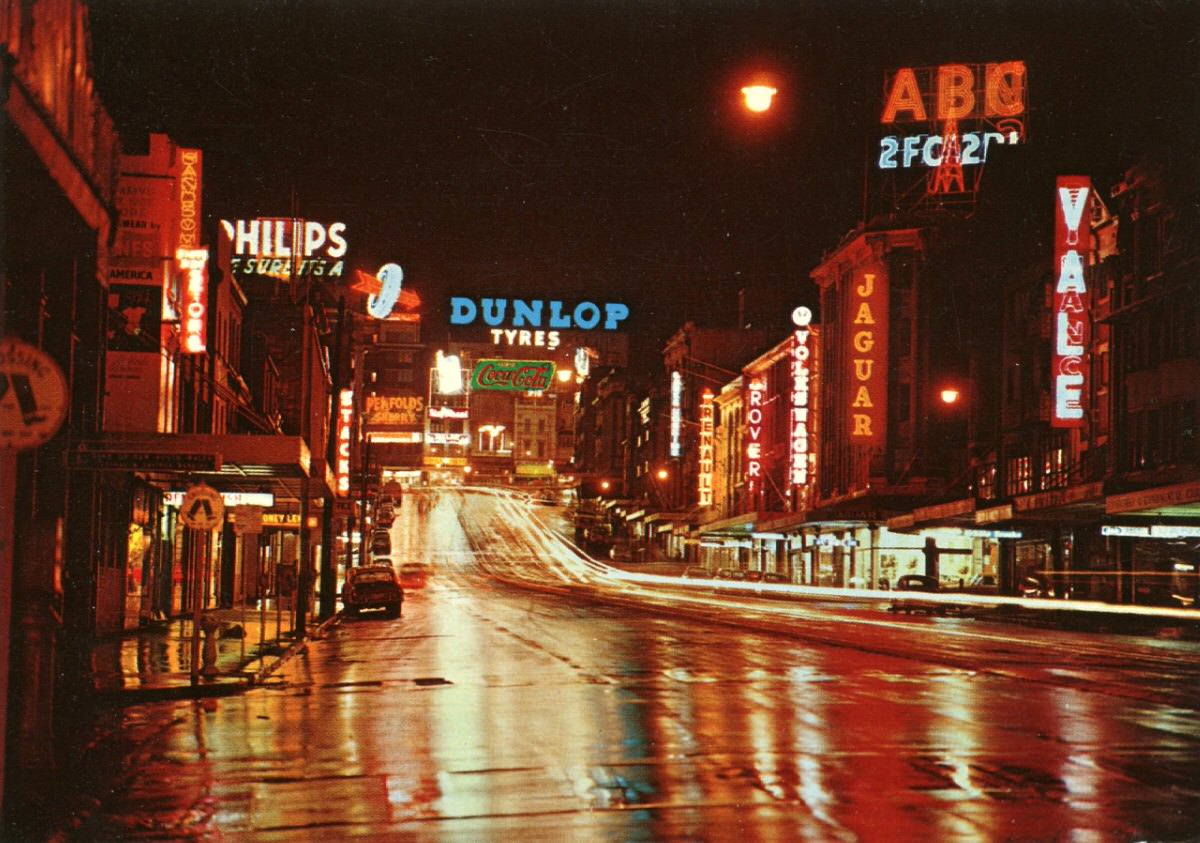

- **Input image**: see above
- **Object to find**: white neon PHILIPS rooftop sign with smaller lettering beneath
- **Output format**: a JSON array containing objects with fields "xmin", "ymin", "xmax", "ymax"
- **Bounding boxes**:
[{"xmin": 221, "ymin": 219, "xmax": 347, "ymax": 280}]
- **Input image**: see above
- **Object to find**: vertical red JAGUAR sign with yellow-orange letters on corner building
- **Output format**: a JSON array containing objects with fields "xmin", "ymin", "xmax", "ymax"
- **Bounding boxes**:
[{"xmin": 846, "ymin": 267, "xmax": 888, "ymax": 446}]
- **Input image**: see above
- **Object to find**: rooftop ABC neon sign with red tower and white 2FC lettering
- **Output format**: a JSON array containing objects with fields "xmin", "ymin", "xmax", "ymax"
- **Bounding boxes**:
[{"xmin": 877, "ymin": 61, "xmax": 1026, "ymax": 209}]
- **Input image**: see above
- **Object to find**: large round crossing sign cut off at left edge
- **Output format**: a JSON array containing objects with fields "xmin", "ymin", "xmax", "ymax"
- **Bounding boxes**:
[{"xmin": 0, "ymin": 339, "xmax": 67, "ymax": 450}]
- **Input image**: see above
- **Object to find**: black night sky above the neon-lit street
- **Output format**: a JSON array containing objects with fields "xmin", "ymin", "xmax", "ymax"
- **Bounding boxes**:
[{"xmin": 91, "ymin": 0, "xmax": 1200, "ymax": 362}]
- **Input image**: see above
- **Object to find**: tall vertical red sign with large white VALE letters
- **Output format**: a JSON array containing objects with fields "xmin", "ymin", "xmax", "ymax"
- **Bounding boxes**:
[{"xmin": 1051, "ymin": 175, "xmax": 1092, "ymax": 428}]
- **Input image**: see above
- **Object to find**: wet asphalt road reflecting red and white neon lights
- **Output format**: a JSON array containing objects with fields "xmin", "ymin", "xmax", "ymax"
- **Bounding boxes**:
[{"xmin": 44, "ymin": 492, "xmax": 1200, "ymax": 841}]
